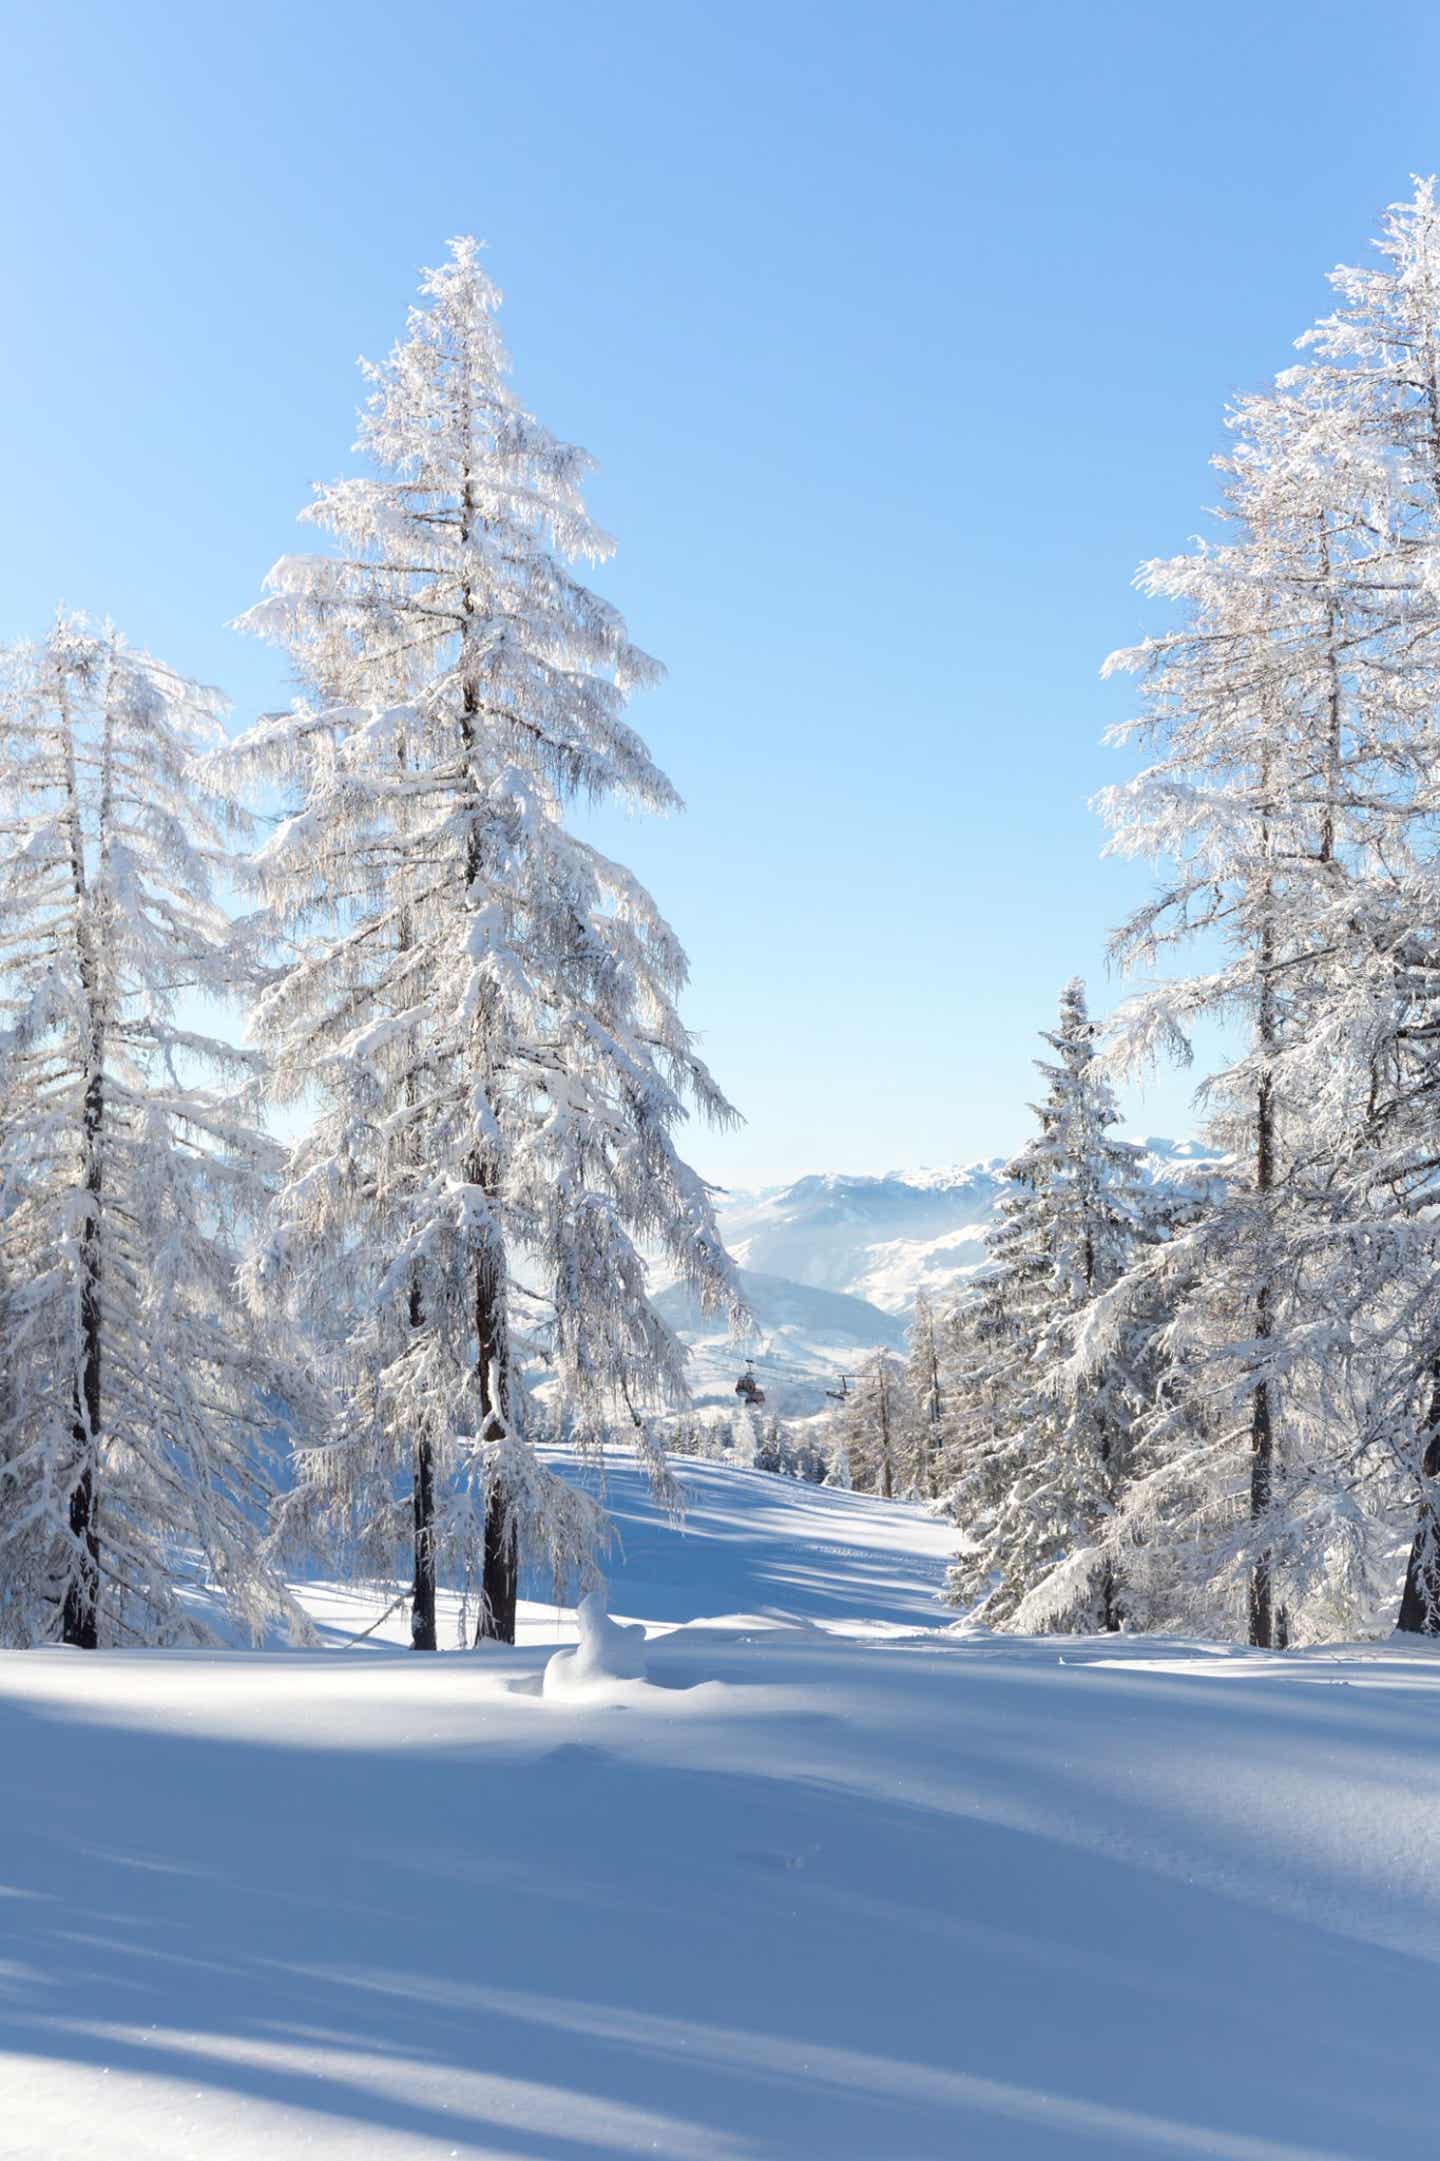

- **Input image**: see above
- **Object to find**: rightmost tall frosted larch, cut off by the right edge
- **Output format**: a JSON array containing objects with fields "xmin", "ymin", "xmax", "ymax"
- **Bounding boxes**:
[{"xmin": 1302, "ymin": 179, "xmax": 1440, "ymax": 1634}]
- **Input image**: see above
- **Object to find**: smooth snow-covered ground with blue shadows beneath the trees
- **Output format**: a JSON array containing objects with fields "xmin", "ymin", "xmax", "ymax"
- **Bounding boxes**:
[{"xmin": 0, "ymin": 1461, "xmax": 1440, "ymax": 2161}]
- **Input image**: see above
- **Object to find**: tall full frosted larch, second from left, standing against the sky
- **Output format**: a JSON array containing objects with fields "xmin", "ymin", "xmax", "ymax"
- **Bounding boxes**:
[{"xmin": 231, "ymin": 240, "xmax": 739, "ymax": 1649}]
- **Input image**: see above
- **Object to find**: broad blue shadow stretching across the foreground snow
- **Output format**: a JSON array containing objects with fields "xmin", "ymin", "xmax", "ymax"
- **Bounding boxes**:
[{"xmin": 0, "ymin": 1703, "xmax": 1436, "ymax": 2161}]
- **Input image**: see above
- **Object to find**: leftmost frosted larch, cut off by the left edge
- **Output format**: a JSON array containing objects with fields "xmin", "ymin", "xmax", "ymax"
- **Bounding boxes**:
[{"xmin": 0, "ymin": 618, "xmax": 301, "ymax": 1649}]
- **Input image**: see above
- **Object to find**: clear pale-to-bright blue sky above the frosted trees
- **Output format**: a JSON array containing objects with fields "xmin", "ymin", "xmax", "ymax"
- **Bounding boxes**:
[{"xmin": 0, "ymin": 0, "xmax": 1440, "ymax": 1182}]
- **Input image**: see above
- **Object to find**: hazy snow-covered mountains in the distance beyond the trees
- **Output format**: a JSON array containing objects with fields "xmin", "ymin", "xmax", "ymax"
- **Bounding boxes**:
[{"xmin": 657, "ymin": 1139, "xmax": 1213, "ymax": 1418}]
